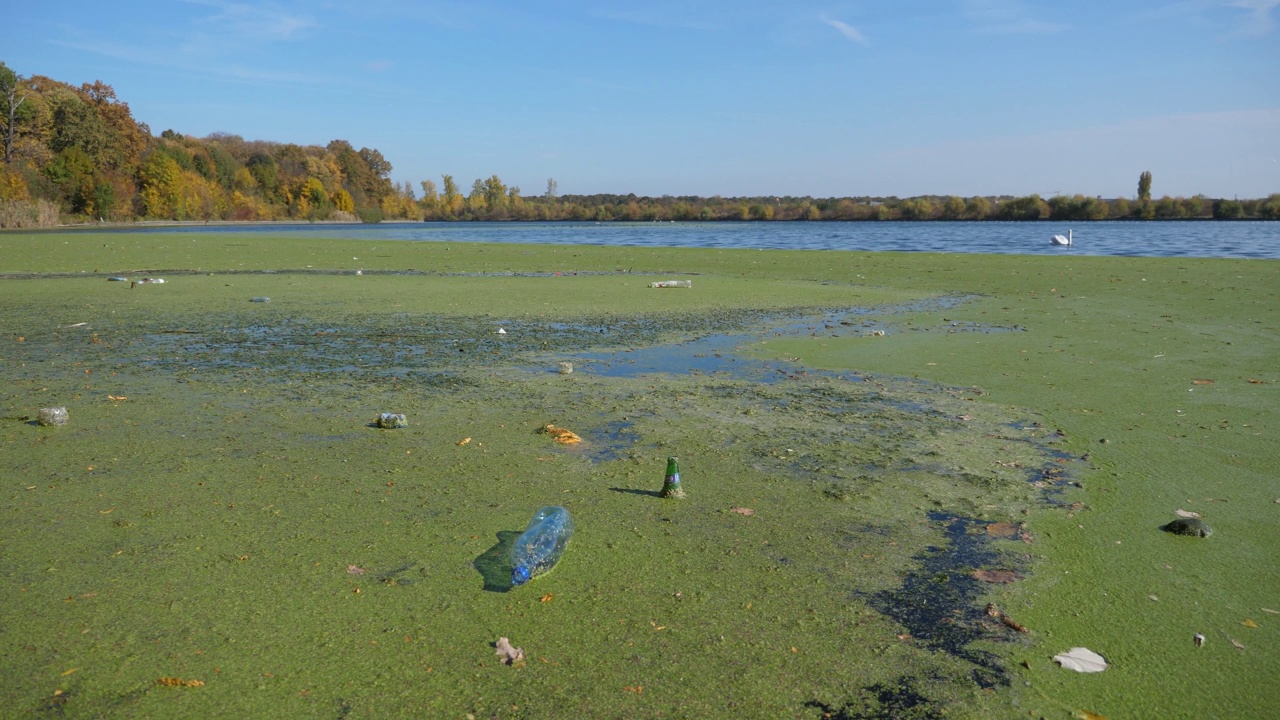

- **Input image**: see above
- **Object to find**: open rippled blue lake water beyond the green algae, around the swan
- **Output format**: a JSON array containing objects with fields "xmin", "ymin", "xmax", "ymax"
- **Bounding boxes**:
[{"xmin": 94, "ymin": 220, "xmax": 1280, "ymax": 259}]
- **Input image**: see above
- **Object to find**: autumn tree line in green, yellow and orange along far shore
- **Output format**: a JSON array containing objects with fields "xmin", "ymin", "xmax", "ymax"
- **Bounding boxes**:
[{"xmin": 0, "ymin": 63, "xmax": 1280, "ymax": 228}]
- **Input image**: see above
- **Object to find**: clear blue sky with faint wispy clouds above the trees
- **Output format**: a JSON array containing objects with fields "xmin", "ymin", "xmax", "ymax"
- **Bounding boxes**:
[{"xmin": 0, "ymin": 0, "xmax": 1280, "ymax": 199}]
